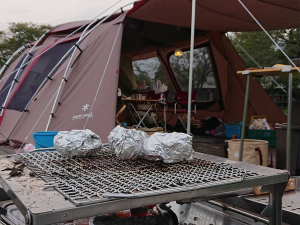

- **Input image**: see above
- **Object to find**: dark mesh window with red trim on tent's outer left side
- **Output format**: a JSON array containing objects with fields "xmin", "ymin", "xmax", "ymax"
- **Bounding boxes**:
[{"xmin": 7, "ymin": 40, "xmax": 77, "ymax": 111}]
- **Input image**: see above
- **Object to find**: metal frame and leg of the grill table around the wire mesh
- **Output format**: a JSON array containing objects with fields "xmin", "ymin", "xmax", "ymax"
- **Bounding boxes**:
[{"xmin": 0, "ymin": 153, "xmax": 289, "ymax": 225}]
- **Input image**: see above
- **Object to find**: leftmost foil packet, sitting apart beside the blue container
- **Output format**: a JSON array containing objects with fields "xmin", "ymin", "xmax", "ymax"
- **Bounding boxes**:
[{"xmin": 54, "ymin": 129, "xmax": 102, "ymax": 158}]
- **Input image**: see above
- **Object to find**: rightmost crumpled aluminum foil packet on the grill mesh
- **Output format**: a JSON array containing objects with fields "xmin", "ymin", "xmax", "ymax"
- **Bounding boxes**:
[{"xmin": 143, "ymin": 132, "xmax": 194, "ymax": 163}]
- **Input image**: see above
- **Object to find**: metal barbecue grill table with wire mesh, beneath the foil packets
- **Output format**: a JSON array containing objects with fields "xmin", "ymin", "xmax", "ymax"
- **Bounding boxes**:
[{"xmin": 0, "ymin": 149, "xmax": 289, "ymax": 225}]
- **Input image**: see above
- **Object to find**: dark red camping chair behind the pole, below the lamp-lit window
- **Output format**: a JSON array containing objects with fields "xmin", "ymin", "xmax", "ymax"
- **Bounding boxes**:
[{"xmin": 158, "ymin": 89, "xmax": 198, "ymax": 130}]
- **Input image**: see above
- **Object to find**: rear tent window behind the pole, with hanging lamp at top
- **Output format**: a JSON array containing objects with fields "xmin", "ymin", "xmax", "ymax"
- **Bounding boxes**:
[{"xmin": 170, "ymin": 47, "xmax": 218, "ymax": 101}]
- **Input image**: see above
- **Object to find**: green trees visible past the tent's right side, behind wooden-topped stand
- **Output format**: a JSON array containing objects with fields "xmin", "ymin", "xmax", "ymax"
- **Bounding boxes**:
[{"xmin": 229, "ymin": 28, "xmax": 300, "ymax": 100}]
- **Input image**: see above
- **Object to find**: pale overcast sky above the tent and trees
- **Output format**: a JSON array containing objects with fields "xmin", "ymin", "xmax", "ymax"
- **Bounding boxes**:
[{"xmin": 0, "ymin": 0, "xmax": 134, "ymax": 30}]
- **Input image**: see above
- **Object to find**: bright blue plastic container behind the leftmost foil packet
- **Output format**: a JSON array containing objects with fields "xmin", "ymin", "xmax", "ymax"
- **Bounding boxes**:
[{"xmin": 32, "ymin": 131, "xmax": 58, "ymax": 149}]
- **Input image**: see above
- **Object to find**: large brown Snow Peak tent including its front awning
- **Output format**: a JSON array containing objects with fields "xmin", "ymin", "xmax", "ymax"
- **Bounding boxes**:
[{"xmin": 0, "ymin": 0, "xmax": 300, "ymax": 143}]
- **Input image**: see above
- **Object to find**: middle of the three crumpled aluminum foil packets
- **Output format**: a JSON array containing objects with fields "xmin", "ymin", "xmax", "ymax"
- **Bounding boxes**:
[{"xmin": 108, "ymin": 126, "xmax": 148, "ymax": 160}]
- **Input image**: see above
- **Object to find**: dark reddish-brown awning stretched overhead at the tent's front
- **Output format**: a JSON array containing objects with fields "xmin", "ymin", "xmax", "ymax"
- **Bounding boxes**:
[{"xmin": 128, "ymin": 0, "xmax": 300, "ymax": 32}]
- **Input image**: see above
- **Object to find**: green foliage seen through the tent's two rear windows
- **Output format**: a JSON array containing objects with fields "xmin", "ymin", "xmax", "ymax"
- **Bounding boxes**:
[{"xmin": 133, "ymin": 47, "xmax": 216, "ymax": 101}]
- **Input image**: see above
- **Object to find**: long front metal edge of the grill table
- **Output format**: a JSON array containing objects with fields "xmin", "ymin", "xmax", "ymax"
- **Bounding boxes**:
[{"xmin": 31, "ymin": 173, "xmax": 289, "ymax": 225}]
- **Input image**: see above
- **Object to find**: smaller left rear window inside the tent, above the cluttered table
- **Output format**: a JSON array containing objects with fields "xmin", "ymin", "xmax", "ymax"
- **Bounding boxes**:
[{"xmin": 132, "ymin": 57, "xmax": 175, "ymax": 101}]
